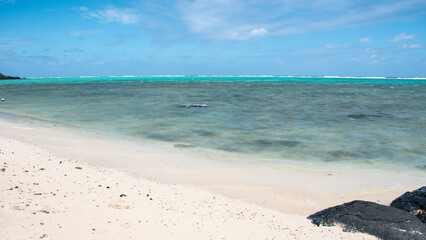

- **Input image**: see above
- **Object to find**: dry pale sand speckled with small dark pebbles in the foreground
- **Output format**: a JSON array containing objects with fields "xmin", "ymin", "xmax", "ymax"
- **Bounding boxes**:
[{"xmin": 0, "ymin": 137, "xmax": 375, "ymax": 239}]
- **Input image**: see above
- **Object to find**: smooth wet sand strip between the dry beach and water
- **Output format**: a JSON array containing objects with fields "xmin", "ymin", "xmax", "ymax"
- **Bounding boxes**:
[{"xmin": 0, "ymin": 119, "xmax": 425, "ymax": 215}]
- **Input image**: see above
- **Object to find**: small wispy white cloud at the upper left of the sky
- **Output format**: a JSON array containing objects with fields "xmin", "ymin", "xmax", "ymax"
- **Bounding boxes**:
[{"xmin": 78, "ymin": 5, "xmax": 140, "ymax": 24}]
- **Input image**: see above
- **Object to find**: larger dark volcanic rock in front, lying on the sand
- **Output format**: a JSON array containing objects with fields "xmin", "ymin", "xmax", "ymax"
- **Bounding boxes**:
[{"xmin": 308, "ymin": 201, "xmax": 426, "ymax": 240}]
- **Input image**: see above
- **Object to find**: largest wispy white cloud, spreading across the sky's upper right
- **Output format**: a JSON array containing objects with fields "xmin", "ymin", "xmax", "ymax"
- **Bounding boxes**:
[{"xmin": 177, "ymin": 0, "xmax": 426, "ymax": 41}]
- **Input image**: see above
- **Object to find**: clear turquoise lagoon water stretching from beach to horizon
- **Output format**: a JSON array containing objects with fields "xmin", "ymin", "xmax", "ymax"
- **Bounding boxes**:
[{"xmin": 0, "ymin": 77, "xmax": 426, "ymax": 167}]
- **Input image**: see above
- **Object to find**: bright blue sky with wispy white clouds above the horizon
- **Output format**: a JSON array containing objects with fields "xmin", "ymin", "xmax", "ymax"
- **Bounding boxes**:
[{"xmin": 0, "ymin": 0, "xmax": 426, "ymax": 77}]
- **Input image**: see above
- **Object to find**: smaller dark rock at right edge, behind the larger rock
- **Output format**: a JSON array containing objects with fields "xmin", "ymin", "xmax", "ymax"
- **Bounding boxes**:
[{"xmin": 391, "ymin": 186, "xmax": 426, "ymax": 224}]
